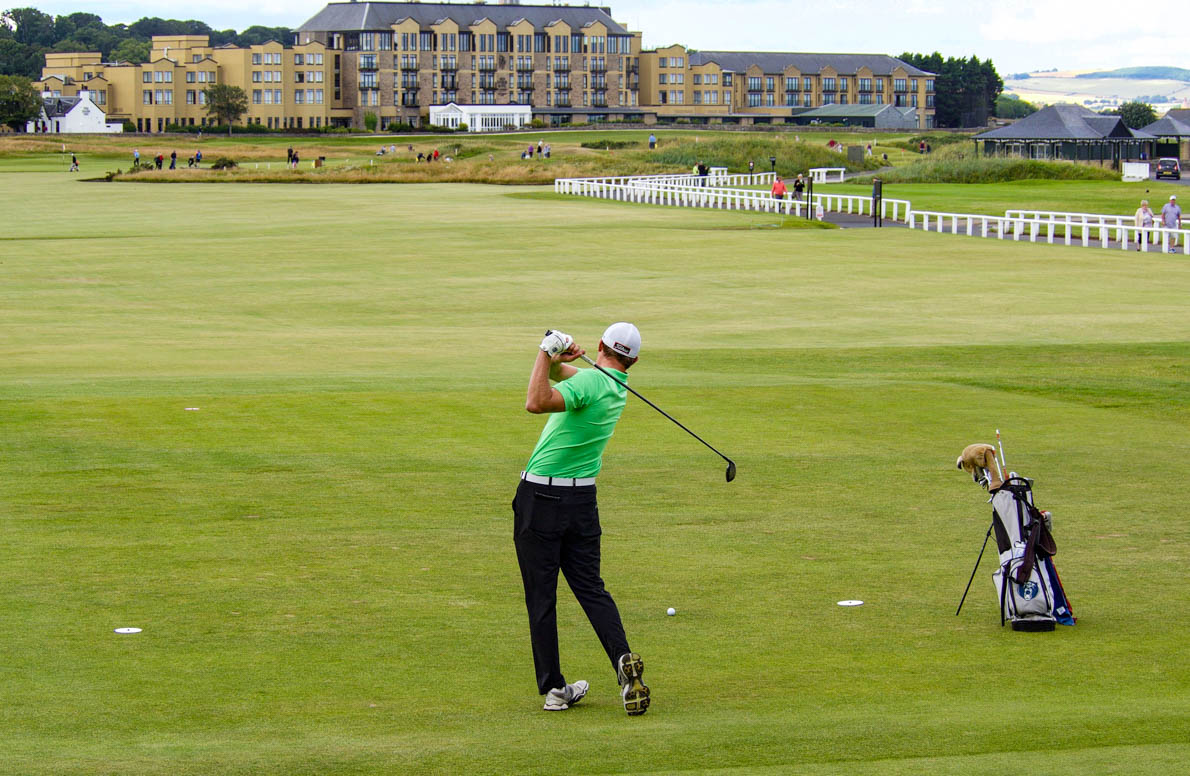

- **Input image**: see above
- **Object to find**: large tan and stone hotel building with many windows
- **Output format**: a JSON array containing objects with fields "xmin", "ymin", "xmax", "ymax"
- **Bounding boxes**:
[{"xmin": 37, "ymin": 2, "xmax": 934, "ymax": 132}]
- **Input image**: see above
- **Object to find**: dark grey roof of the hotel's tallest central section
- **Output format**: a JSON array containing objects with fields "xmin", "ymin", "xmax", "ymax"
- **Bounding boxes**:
[{"xmin": 298, "ymin": 2, "xmax": 628, "ymax": 35}]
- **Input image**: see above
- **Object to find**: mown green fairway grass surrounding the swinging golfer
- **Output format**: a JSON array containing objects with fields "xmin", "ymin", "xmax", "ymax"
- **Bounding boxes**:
[{"xmin": 0, "ymin": 157, "xmax": 1190, "ymax": 776}]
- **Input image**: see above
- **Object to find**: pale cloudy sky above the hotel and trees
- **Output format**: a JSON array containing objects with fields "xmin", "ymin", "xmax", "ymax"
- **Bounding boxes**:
[{"xmin": 20, "ymin": 0, "xmax": 1190, "ymax": 75}]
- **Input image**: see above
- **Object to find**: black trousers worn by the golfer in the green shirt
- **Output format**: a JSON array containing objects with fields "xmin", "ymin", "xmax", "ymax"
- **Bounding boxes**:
[{"xmin": 513, "ymin": 480, "xmax": 630, "ymax": 695}]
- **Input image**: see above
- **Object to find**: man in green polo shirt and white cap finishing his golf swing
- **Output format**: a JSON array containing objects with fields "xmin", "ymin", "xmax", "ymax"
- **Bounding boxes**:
[{"xmin": 513, "ymin": 323, "xmax": 649, "ymax": 716}]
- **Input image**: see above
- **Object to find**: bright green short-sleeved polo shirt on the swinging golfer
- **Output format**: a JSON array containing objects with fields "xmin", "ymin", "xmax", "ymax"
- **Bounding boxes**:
[{"xmin": 525, "ymin": 369, "xmax": 628, "ymax": 477}]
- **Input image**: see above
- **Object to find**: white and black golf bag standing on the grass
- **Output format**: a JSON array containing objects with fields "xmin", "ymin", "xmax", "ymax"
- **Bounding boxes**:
[{"xmin": 991, "ymin": 474, "xmax": 1075, "ymax": 631}]
